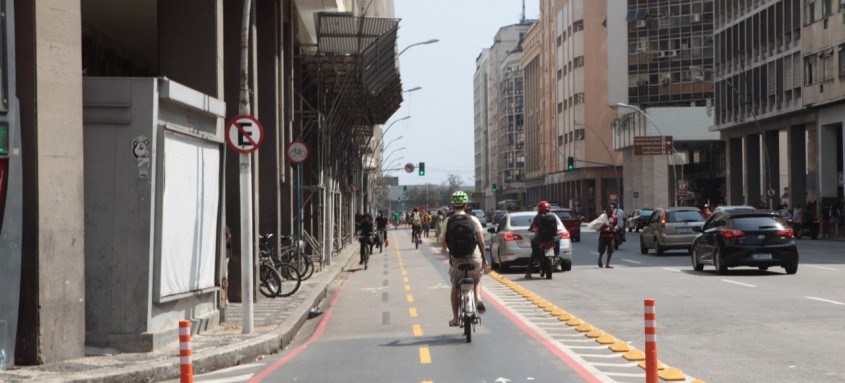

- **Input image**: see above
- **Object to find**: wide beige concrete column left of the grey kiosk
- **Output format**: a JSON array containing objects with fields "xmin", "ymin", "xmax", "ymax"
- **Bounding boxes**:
[{"xmin": 17, "ymin": 0, "xmax": 85, "ymax": 363}]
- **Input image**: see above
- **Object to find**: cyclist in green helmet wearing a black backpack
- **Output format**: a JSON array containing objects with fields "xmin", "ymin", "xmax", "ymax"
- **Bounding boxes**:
[{"xmin": 440, "ymin": 191, "xmax": 487, "ymax": 327}]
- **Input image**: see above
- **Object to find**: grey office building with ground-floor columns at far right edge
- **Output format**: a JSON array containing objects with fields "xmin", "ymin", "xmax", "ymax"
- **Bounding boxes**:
[{"xmin": 715, "ymin": 0, "xmax": 845, "ymax": 214}]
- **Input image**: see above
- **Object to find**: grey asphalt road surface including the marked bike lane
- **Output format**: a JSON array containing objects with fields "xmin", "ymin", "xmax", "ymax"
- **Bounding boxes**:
[{"xmin": 175, "ymin": 225, "xmax": 845, "ymax": 383}]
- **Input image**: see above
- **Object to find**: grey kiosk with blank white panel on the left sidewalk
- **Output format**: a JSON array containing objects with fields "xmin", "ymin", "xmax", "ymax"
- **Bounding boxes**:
[{"xmin": 83, "ymin": 77, "xmax": 225, "ymax": 352}]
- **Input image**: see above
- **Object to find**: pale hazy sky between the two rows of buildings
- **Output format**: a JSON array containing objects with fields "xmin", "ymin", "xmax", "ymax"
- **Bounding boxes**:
[{"xmin": 383, "ymin": 0, "xmax": 540, "ymax": 185}]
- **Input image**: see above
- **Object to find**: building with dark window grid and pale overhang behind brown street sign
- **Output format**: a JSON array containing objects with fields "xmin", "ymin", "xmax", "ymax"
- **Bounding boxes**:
[{"xmin": 607, "ymin": 0, "xmax": 726, "ymax": 209}]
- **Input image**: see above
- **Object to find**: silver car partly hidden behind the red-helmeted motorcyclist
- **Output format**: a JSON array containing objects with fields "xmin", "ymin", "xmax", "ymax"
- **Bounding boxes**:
[{"xmin": 488, "ymin": 211, "xmax": 572, "ymax": 272}]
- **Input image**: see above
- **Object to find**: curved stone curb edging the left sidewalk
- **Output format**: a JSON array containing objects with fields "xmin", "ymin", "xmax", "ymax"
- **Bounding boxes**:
[{"xmin": 52, "ymin": 244, "xmax": 357, "ymax": 383}]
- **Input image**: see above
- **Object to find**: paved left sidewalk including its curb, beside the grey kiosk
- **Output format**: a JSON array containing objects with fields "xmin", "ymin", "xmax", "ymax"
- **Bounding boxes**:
[{"xmin": 0, "ymin": 243, "xmax": 358, "ymax": 383}]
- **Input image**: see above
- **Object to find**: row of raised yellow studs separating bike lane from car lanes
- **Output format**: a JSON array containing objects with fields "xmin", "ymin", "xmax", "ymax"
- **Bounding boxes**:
[{"xmin": 487, "ymin": 271, "xmax": 688, "ymax": 383}]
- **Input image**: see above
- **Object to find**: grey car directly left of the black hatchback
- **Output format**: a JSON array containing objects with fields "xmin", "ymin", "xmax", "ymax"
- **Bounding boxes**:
[{"xmin": 640, "ymin": 207, "xmax": 704, "ymax": 255}]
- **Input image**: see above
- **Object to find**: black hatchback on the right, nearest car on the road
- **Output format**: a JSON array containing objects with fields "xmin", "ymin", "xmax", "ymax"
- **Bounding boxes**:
[{"xmin": 691, "ymin": 211, "xmax": 798, "ymax": 274}]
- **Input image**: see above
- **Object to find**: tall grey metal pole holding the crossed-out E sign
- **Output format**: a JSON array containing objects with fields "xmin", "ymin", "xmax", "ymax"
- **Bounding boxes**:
[{"xmin": 238, "ymin": 0, "xmax": 254, "ymax": 334}]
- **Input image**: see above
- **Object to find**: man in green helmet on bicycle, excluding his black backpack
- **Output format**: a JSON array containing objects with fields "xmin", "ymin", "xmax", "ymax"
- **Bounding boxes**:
[{"xmin": 440, "ymin": 191, "xmax": 487, "ymax": 327}]
